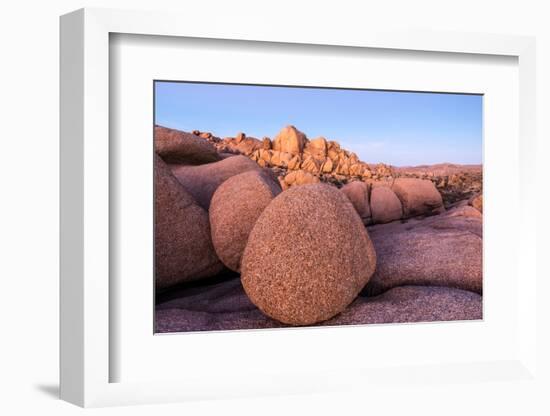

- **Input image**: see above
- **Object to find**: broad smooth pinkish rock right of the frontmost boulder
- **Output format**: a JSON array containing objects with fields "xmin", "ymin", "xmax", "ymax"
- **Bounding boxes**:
[{"xmin": 366, "ymin": 214, "xmax": 483, "ymax": 295}]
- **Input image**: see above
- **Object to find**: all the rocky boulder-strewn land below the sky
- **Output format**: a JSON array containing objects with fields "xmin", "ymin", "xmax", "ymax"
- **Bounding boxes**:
[{"xmin": 154, "ymin": 125, "xmax": 483, "ymax": 332}]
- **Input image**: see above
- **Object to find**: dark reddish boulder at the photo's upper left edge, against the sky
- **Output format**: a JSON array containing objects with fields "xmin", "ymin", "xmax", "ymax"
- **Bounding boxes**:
[{"xmin": 155, "ymin": 126, "xmax": 221, "ymax": 165}]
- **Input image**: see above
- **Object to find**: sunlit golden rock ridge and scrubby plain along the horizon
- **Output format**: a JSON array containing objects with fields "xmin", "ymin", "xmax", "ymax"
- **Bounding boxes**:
[{"xmin": 192, "ymin": 126, "xmax": 483, "ymax": 208}]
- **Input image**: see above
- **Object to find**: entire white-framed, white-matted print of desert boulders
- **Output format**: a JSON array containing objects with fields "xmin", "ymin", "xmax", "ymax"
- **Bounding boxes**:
[{"xmin": 61, "ymin": 9, "xmax": 538, "ymax": 406}]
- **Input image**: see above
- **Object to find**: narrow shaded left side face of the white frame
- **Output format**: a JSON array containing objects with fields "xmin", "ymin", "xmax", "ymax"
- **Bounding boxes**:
[{"xmin": 59, "ymin": 9, "xmax": 84, "ymax": 406}]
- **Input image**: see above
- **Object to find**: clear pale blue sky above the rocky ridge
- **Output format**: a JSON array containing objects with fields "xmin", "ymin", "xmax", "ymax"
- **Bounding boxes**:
[{"xmin": 155, "ymin": 82, "xmax": 483, "ymax": 166}]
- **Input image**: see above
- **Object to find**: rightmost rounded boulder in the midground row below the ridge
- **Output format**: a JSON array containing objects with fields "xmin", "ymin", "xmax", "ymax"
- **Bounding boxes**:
[{"xmin": 392, "ymin": 178, "xmax": 445, "ymax": 218}]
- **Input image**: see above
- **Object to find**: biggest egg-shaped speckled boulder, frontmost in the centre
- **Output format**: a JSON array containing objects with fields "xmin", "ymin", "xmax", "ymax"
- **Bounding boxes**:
[{"xmin": 241, "ymin": 184, "xmax": 376, "ymax": 325}]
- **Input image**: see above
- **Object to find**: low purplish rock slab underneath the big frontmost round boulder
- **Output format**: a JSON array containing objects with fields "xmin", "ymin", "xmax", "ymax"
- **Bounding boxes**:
[{"xmin": 155, "ymin": 278, "xmax": 483, "ymax": 332}]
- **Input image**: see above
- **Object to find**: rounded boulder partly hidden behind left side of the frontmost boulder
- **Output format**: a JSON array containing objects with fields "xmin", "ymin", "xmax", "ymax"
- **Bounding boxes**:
[{"xmin": 209, "ymin": 170, "xmax": 281, "ymax": 272}]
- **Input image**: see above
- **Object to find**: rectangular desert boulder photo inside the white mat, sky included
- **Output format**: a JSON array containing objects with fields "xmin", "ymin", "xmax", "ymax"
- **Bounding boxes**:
[{"xmin": 151, "ymin": 80, "xmax": 483, "ymax": 333}]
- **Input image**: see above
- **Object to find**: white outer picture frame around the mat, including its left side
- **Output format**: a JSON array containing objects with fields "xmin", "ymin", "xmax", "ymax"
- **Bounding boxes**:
[{"xmin": 60, "ymin": 9, "xmax": 539, "ymax": 407}]
